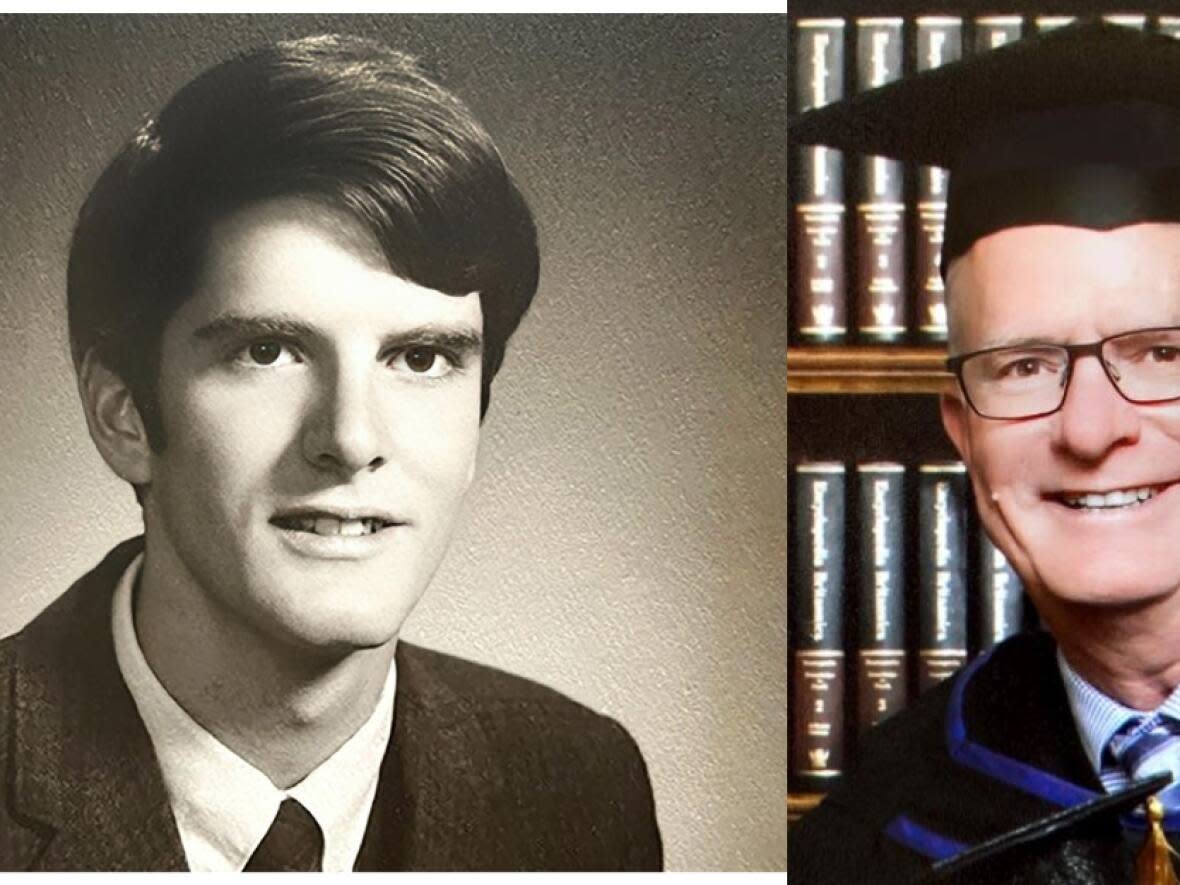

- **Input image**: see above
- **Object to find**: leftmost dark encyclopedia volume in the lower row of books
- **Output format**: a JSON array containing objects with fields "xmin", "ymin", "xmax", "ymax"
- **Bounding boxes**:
[{"xmin": 791, "ymin": 463, "xmax": 845, "ymax": 780}]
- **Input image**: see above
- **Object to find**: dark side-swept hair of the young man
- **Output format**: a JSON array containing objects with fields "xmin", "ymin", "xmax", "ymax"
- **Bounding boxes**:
[{"xmin": 67, "ymin": 35, "xmax": 539, "ymax": 450}]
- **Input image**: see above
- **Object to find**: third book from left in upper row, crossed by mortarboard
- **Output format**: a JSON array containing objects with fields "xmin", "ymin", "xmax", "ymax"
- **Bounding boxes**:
[{"xmin": 915, "ymin": 15, "xmax": 963, "ymax": 341}]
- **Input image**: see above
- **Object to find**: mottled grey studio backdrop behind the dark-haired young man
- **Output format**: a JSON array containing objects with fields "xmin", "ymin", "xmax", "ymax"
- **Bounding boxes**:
[{"xmin": 0, "ymin": 14, "xmax": 787, "ymax": 870}]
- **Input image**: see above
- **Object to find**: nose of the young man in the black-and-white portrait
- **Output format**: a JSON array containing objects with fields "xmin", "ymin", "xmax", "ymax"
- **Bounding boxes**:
[{"xmin": 302, "ymin": 366, "xmax": 388, "ymax": 477}]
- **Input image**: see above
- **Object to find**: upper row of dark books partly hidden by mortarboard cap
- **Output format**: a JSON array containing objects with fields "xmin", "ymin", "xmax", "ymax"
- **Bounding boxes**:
[{"xmin": 788, "ymin": 14, "xmax": 1180, "ymax": 343}]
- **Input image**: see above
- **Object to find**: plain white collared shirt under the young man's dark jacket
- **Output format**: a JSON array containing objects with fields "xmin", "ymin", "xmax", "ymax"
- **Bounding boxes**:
[{"xmin": 111, "ymin": 553, "xmax": 398, "ymax": 872}]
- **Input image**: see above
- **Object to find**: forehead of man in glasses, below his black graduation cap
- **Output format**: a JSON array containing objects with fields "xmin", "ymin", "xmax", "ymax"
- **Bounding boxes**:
[{"xmin": 946, "ymin": 222, "xmax": 1180, "ymax": 353}]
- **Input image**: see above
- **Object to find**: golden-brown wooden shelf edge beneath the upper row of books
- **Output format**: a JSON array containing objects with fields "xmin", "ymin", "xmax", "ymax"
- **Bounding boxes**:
[{"xmin": 787, "ymin": 345, "xmax": 955, "ymax": 393}]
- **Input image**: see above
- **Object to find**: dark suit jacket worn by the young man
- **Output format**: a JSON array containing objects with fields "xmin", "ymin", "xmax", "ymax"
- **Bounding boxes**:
[{"xmin": 0, "ymin": 540, "xmax": 662, "ymax": 871}]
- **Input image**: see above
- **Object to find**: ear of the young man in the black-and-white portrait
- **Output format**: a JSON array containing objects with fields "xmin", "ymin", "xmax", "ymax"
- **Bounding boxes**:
[{"xmin": 78, "ymin": 350, "xmax": 151, "ymax": 486}]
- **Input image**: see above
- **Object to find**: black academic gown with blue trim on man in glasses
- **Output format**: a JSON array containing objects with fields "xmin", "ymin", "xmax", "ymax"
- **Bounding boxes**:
[{"xmin": 788, "ymin": 632, "xmax": 1180, "ymax": 885}]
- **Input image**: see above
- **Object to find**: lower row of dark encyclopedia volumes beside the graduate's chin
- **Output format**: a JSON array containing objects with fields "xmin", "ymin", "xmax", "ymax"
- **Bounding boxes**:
[{"xmin": 788, "ymin": 461, "xmax": 1035, "ymax": 791}]
